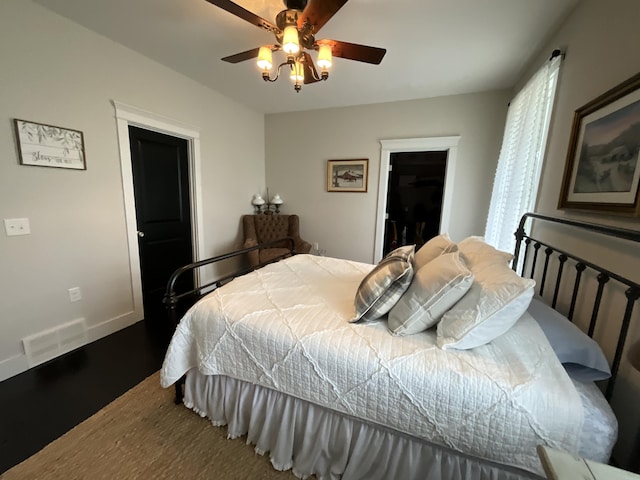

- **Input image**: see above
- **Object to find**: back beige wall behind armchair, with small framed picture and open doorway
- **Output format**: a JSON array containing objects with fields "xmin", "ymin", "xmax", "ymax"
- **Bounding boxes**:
[{"xmin": 265, "ymin": 92, "xmax": 509, "ymax": 263}]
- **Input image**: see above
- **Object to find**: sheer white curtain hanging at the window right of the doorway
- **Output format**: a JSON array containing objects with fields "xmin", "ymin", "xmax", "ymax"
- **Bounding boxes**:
[{"xmin": 485, "ymin": 55, "xmax": 562, "ymax": 252}]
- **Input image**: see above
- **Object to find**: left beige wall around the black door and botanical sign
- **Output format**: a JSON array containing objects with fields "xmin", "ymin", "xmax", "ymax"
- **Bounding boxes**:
[{"xmin": 0, "ymin": 0, "xmax": 265, "ymax": 380}]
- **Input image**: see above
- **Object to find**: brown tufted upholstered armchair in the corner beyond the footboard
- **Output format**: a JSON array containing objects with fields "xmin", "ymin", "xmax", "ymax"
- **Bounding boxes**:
[{"xmin": 242, "ymin": 214, "xmax": 311, "ymax": 267}]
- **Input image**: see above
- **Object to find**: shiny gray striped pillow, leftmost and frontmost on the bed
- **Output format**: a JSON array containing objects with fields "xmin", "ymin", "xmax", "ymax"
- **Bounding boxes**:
[{"xmin": 350, "ymin": 245, "xmax": 415, "ymax": 323}]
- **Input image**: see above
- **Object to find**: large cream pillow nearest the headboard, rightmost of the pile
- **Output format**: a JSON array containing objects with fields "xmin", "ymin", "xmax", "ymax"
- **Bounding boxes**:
[{"xmin": 437, "ymin": 256, "xmax": 535, "ymax": 350}]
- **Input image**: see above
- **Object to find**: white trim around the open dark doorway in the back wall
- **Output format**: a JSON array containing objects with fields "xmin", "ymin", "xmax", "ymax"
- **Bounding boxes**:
[{"xmin": 373, "ymin": 135, "xmax": 460, "ymax": 263}]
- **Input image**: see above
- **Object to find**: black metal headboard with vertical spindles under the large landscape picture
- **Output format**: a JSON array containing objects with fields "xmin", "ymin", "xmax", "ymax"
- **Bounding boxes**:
[{"xmin": 513, "ymin": 213, "xmax": 640, "ymax": 400}]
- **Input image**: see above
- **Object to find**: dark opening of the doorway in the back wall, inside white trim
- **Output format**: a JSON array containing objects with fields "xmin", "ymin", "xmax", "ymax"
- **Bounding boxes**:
[{"xmin": 382, "ymin": 150, "xmax": 447, "ymax": 255}]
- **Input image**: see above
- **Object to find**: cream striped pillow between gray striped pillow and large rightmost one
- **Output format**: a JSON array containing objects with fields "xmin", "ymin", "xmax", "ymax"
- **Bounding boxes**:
[{"xmin": 389, "ymin": 252, "xmax": 473, "ymax": 335}]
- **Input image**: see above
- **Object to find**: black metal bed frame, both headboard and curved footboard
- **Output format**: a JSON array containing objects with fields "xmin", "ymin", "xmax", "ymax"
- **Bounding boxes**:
[{"xmin": 163, "ymin": 213, "xmax": 640, "ymax": 404}]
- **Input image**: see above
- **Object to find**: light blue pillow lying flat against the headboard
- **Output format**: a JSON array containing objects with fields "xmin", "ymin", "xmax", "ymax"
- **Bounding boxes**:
[{"xmin": 527, "ymin": 297, "xmax": 611, "ymax": 382}]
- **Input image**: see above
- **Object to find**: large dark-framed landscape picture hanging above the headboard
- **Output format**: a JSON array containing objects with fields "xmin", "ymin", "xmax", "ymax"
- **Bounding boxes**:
[{"xmin": 558, "ymin": 73, "xmax": 640, "ymax": 216}]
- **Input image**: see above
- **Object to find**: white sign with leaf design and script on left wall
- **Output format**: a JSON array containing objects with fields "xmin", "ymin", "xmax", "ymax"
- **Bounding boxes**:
[{"xmin": 13, "ymin": 118, "xmax": 87, "ymax": 170}]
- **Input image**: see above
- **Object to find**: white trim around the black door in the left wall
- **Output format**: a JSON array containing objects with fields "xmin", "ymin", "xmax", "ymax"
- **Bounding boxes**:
[{"xmin": 112, "ymin": 100, "xmax": 204, "ymax": 320}]
